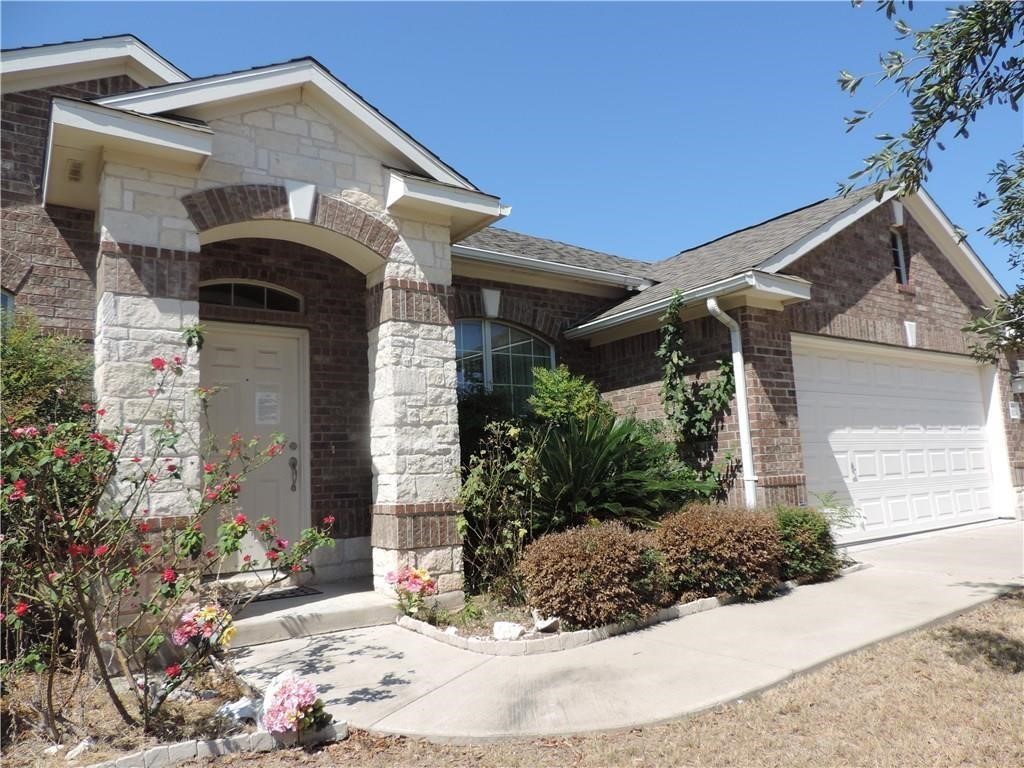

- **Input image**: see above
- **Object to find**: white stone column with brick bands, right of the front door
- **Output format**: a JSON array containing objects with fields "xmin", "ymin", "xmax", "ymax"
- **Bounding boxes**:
[{"xmin": 367, "ymin": 278, "xmax": 462, "ymax": 593}]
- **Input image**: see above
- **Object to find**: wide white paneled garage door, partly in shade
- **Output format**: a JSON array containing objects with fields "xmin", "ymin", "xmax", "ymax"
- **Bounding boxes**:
[{"xmin": 794, "ymin": 336, "xmax": 995, "ymax": 541}]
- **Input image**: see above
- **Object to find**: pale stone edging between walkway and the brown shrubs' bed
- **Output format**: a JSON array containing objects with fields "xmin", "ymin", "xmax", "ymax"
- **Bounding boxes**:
[{"xmin": 397, "ymin": 563, "xmax": 868, "ymax": 656}]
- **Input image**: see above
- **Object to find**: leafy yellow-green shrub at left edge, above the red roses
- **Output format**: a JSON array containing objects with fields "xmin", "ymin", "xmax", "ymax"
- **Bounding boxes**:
[{"xmin": 0, "ymin": 312, "xmax": 92, "ymax": 426}]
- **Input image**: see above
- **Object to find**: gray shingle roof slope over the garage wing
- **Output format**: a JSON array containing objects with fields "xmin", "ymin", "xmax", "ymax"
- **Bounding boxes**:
[{"xmin": 594, "ymin": 186, "xmax": 874, "ymax": 319}]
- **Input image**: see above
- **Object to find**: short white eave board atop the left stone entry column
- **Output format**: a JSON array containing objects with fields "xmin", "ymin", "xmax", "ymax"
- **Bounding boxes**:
[{"xmin": 50, "ymin": 98, "xmax": 213, "ymax": 162}]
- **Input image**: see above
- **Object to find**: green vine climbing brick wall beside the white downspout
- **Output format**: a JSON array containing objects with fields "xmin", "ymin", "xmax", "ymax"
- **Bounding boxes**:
[{"xmin": 657, "ymin": 292, "xmax": 736, "ymax": 480}]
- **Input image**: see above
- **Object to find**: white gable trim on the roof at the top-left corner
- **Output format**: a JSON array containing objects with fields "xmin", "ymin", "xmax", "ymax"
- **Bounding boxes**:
[{"xmin": 0, "ymin": 35, "xmax": 188, "ymax": 90}]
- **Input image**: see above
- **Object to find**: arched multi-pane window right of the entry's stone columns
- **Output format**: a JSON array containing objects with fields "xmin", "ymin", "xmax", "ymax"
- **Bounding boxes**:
[{"xmin": 455, "ymin": 319, "xmax": 555, "ymax": 414}]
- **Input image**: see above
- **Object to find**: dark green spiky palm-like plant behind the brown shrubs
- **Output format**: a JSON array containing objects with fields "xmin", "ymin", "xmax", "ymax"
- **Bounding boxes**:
[{"xmin": 535, "ymin": 416, "xmax": 713, "ymax": 534}]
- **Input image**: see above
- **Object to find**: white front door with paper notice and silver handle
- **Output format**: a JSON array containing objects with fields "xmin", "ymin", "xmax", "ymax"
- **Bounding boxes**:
[{"xmin": 200, "ymin": 323, "xmax": 309, "ymax": 571}]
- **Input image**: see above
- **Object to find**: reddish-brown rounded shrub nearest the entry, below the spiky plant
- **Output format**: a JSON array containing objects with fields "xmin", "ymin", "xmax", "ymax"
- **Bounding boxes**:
[{"xmin": 519, "ymin": 522, "xmax": 671, "ymax": 628}]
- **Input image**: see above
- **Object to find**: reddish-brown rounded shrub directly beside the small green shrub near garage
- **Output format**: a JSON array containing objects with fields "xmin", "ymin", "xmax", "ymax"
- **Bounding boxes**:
[{"xmin": 656, "ymin": 504, "xmax": 782, "ymax": 598}]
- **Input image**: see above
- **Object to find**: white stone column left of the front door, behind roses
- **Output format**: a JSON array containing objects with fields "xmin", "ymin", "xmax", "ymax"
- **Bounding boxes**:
[{"xmin": 94, "ymin": 159, "xmax": 202, "ymax": 527}]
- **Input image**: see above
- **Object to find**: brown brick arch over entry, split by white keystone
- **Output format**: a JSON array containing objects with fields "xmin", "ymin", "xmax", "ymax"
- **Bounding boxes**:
[{"xmin": 181, "ymin": 184, "xmax": 398, "ymax": 260}]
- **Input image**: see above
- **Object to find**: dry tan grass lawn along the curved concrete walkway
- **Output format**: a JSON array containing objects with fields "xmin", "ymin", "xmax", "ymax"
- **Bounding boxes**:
[{"xmin": 201, "ymin": 592, "xmax": 1024, "ymax": 768}]
